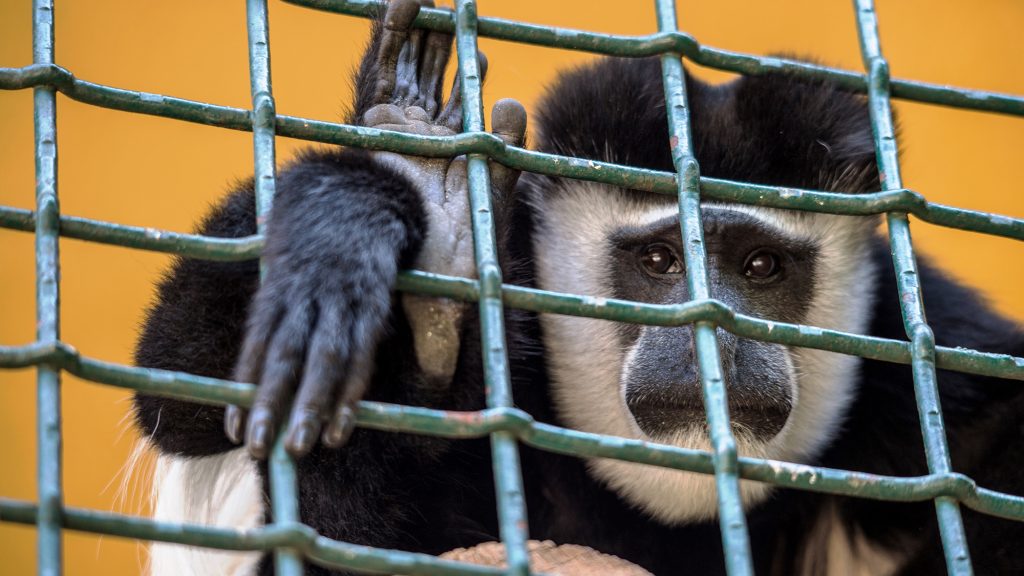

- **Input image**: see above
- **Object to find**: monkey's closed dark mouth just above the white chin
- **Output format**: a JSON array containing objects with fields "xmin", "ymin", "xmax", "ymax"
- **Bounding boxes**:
[{"xmin": 627, "ymin": 397, "xmax": 791, "ymax": 442}]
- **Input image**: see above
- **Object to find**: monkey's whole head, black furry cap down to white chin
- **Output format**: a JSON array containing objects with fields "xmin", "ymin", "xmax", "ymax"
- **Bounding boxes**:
[{"xmin": 525, "ymin": 59, "xmax": 878, "ymax": 523}]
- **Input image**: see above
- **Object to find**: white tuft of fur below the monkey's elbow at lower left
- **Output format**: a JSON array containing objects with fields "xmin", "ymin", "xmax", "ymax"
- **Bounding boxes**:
[{"xmin": 148, "ymin": 449, "xmax": 264, "ymax": 576}]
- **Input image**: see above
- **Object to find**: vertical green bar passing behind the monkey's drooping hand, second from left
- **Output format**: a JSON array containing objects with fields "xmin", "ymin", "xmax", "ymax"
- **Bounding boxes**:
[{"xmin": 246, "ymin": 0, "xmax": 303, "ymax": 576}]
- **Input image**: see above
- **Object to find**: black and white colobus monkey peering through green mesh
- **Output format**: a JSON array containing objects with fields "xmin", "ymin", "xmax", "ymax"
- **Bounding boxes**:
[{"xmin": 136, "ymin": 0, "xmax": 1024, "ymax": 575}]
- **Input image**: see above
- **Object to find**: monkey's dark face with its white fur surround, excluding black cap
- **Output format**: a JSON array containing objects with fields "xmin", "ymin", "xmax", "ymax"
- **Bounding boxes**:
[{"xmin": 535, "ymin": 182, "xmax": 874, "ymax": 523}]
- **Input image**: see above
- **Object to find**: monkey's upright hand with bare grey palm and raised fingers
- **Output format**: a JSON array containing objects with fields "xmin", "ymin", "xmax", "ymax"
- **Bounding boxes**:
[{"xmin": 357, "ymin": 0, "xmax": 526, "ymax": 387}]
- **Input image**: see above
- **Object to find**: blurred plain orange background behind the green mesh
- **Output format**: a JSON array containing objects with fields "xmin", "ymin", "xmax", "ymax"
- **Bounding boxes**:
[{"xmin": 0, "ymin": 0, "xmax": 1024, "ymax": 575}]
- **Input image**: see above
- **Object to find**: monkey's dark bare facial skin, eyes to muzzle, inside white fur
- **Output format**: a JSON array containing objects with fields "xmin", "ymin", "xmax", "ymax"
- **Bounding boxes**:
[{"xmin": 609, "ymin": 205, "xmax": 817, "ymax": 442}]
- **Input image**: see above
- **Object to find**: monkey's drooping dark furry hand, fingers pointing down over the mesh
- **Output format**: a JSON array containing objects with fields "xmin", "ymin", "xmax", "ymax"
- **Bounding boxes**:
[{"xmin": 225, "ymin": 146, "xmax": 426, "ymax": 457}]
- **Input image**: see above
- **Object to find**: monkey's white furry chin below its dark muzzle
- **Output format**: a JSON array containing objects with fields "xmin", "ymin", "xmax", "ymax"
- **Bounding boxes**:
[{"xmin": 588, "ymin": 426, "xmax": 771, "ymax": 525}]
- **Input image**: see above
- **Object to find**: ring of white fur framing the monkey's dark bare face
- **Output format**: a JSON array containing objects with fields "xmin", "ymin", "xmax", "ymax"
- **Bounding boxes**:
[{"xmin": 535, "ymin": 181, "xmax": 876, "ymax": 524}]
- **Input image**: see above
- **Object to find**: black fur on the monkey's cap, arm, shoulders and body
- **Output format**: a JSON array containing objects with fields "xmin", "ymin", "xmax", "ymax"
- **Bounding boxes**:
[{"xmin": 136, "ymin": 32, "xmax": 1024, "ymax": 575}]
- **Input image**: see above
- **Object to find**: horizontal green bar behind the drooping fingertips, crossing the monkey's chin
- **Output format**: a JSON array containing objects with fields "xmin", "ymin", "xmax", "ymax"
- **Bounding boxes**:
[{"xmin": 0, "ymin": 342, "xmax": 1024, "ymax": 521}]
